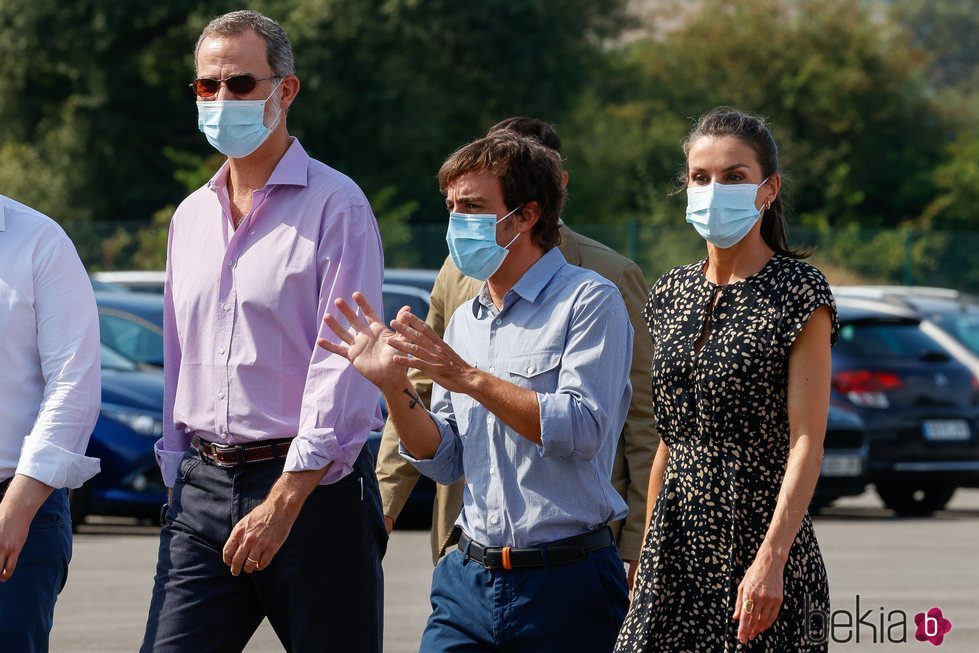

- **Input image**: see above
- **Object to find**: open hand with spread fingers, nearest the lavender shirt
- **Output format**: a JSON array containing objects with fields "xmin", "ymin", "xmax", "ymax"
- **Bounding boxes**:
[{"xmin": 316, "ymin": 292, "xmax": 406, "ymax": 388}]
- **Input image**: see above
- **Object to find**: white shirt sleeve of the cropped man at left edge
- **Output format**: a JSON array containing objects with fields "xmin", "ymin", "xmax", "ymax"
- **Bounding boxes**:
[{"xmin": 16, "ymin": 236, "xmax": 102, "ymax": 488}]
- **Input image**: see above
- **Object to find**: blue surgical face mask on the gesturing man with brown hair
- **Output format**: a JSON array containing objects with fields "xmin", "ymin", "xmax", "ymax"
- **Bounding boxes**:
[{"xmin": 445, "ymin": 206, "xmax": 520, "ymax": 281}]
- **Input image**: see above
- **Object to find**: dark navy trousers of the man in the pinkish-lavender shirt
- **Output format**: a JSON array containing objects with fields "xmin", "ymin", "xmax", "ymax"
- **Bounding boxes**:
[{"xmin": 140, "ymin": 447, "xmax": 387, "ymax": 653}]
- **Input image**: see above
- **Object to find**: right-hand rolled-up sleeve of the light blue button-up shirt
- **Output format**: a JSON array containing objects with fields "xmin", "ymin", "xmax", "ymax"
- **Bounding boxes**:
[{"xmin": 537, "ymin": 284, "xmax": 633, "ymax": 460}]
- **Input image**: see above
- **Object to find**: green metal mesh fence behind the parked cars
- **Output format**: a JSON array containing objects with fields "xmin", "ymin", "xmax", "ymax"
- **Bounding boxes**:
[{"xmin": 64, "ymin": 220, "xmax": 979, "ymax": 294}]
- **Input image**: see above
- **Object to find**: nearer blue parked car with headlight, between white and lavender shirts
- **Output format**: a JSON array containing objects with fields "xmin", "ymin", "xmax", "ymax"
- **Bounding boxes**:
[{"xmin": 70, "ymin": 344, "xmax": 166, "ymax": 527}]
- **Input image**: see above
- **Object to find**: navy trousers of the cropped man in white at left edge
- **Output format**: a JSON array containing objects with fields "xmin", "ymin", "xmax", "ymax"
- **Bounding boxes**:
[{"xmin": 0, "ymin": 490, "xmax": 71, "ymax": 653}]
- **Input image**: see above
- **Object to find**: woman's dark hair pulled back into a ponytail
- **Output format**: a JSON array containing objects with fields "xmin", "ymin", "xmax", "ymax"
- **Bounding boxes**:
[{"xmin": 681, "ymin": 107, "xmax": 812, "ymax": 259}]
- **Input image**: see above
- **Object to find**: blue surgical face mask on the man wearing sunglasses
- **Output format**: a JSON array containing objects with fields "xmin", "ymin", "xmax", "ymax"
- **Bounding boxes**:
[{"xmin": 197, "ymin": 79, "xmax": 282, "ymax": 159}]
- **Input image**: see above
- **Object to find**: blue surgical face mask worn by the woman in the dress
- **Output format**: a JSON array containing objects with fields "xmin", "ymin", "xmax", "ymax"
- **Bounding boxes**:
[{"xmin": 687, "ymin": 179, "xmax": 768, "ymax": 249}]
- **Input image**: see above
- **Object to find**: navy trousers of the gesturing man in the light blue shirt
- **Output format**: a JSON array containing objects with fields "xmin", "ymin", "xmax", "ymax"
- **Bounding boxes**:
[{"xmin": 421, "ymin": 546, "xmax": 629, "ymax": 653}]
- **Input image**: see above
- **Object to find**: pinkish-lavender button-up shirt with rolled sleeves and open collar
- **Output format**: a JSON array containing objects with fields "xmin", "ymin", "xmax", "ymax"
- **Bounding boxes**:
[{"xmin": 156, "ymin": 140, "xmax": 384, "ymax": 487}]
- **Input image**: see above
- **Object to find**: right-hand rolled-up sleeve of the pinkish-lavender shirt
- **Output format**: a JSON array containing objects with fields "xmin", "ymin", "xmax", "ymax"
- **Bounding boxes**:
[{"xmin": 284, "ymin": 203, "xmax": 384, "ymax": 484}]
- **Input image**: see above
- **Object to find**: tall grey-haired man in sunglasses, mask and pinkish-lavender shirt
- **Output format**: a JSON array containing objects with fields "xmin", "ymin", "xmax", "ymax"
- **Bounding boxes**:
[{"xmin": 142, "ymin": 11, "xmax": 386, "ymax": 653}]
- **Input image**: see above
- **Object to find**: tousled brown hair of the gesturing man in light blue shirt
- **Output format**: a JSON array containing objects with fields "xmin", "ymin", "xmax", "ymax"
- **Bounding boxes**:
[{"xmin": 438, "ymin": 130, "xmax": 565, "ymax": 252}]
